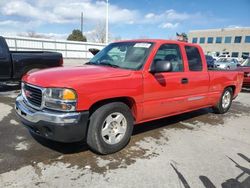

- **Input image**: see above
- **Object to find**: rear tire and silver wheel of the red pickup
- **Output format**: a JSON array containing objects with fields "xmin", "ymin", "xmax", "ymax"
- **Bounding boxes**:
[{"xmin": 213, "ymin": 87, "xmax": 233, "ymax": 114}]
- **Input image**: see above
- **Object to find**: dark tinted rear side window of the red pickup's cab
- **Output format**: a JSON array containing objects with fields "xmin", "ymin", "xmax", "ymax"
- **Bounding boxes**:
[{"xmin": 185, "ymin": 46, "xmax": 202, "ymax": 71}]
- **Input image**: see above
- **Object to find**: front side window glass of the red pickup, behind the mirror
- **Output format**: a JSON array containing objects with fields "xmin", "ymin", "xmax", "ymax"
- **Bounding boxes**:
[{"xmin": 154, "ymin": 44, "xmax": 184, "ymax": 72}]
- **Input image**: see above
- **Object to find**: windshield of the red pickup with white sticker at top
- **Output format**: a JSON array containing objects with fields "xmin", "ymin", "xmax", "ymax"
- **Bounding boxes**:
[{"xmin": 88, "ymin": 42, "xmax": 153, "ymax": 70}]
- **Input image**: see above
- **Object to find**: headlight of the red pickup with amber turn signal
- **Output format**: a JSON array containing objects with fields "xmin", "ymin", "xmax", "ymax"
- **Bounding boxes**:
[{"xmin": 44, "ymin": 88, "xmax": 77, "ymax": 111}]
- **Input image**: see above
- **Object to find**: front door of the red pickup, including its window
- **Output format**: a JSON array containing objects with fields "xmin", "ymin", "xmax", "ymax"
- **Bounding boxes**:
[{"xmin": 143, "ymin": 44, "xmax": 187, "ymax": 120}]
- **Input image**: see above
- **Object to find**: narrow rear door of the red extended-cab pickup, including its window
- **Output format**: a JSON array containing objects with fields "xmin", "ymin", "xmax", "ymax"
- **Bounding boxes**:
[{"xmin": 185, "ymin": 45, "xmax": 210, "ymax": 110}]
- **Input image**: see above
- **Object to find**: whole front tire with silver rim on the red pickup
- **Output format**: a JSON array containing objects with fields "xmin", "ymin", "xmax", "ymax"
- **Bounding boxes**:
[{"xmin": 87, "ymin": 102, "xmax": 134, "ymax": 154}]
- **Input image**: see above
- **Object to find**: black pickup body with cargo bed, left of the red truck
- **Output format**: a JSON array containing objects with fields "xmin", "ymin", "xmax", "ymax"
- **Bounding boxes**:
[{"xmin": 0, "ymin": 36, "xmax": 63, "ymax": 81}]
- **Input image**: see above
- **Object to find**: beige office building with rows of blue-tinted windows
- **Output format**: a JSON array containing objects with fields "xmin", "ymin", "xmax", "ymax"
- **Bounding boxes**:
[{"xmin": 188, "ymin": 27, "xmax": 250, "ymax": 58}]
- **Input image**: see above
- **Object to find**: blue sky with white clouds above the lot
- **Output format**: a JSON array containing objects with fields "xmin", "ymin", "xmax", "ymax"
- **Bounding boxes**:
[{"xmin": 0, "ymin": 0, "xmax": 250, "ymax": 40}]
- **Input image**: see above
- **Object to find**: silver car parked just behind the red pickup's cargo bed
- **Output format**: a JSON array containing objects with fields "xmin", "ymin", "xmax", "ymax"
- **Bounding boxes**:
[{"xmin": 214, "ymin": 58, "xmax": 240, "ymax": 69}]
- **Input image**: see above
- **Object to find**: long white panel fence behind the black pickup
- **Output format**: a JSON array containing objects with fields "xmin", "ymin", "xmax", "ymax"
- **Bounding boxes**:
[{"xmin": 4, "ymin": 36, "xmax": 105, "ymax": 59}]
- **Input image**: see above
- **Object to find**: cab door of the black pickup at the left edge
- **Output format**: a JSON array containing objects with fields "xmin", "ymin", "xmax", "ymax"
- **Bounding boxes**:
[{"xmin": 0, "ymin": 37, "xmax": 12, "ymax": 80}]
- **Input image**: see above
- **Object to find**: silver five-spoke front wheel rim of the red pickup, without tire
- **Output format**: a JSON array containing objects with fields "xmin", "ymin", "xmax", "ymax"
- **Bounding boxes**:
[{"xmin": 101, "ymin": 112, "xmax": 127, "ymax": 145}]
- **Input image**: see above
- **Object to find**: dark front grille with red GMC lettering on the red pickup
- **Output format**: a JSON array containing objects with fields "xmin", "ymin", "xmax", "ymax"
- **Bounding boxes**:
[{"xmin": 23, "ymin": 84, "xmax": 42, "ymax": 108}]
